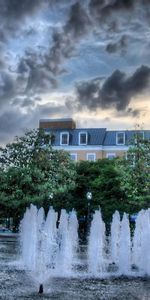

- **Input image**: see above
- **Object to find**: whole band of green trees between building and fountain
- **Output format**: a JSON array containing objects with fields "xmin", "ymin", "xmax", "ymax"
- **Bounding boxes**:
[{"xmin": 0, "ymin": 130, "xmax": 150, "ymax": 222}]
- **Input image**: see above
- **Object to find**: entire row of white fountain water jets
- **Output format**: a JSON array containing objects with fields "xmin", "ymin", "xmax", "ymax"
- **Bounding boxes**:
[{"xmin": 20, "ymin": 205, "xmax": 150, "ymax": 293}]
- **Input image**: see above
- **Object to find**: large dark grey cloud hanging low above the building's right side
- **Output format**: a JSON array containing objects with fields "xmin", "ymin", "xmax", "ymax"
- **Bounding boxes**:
[{"xmin": 76, "ymin": 66, "xmax": 150, "ymax": 111}]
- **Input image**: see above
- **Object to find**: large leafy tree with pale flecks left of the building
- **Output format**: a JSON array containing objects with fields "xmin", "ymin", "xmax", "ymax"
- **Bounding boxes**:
[{"xmin": 0, "ymin": 130, "xmax": 76, "ymax": 220}]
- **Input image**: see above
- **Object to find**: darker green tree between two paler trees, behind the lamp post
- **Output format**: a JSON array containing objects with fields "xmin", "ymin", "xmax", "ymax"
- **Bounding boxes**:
[{"xmin": 71, "ymin": 159, "xmax": 126, "ymax": 221}]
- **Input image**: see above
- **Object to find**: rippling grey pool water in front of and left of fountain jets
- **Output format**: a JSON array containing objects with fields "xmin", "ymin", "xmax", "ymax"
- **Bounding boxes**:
[{"xmin": 0, "ymin": 238, "xmax": 150, "ymax": 300}]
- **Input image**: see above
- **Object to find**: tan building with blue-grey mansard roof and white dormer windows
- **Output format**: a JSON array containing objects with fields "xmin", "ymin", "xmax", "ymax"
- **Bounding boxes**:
[{"xmin": 39, "ymin": 118, "xmax": 150, "ymax": 161}]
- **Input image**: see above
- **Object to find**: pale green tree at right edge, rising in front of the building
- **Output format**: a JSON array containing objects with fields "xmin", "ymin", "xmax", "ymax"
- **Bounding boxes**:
[{"xmin": 116, "ymin": 132, "xmax": 150, "ymax": 210}]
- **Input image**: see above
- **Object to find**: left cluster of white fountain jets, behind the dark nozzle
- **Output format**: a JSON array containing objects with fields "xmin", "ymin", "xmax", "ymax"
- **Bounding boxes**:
[{"xmin": 20, "ymin": 205, "xmax": 78, "ymax": 283}]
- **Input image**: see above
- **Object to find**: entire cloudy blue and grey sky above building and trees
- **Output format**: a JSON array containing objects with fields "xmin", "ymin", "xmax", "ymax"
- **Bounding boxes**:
[{"xmin": 0, "ymin": 0, "xmax": 150, "ymax": 144}]
